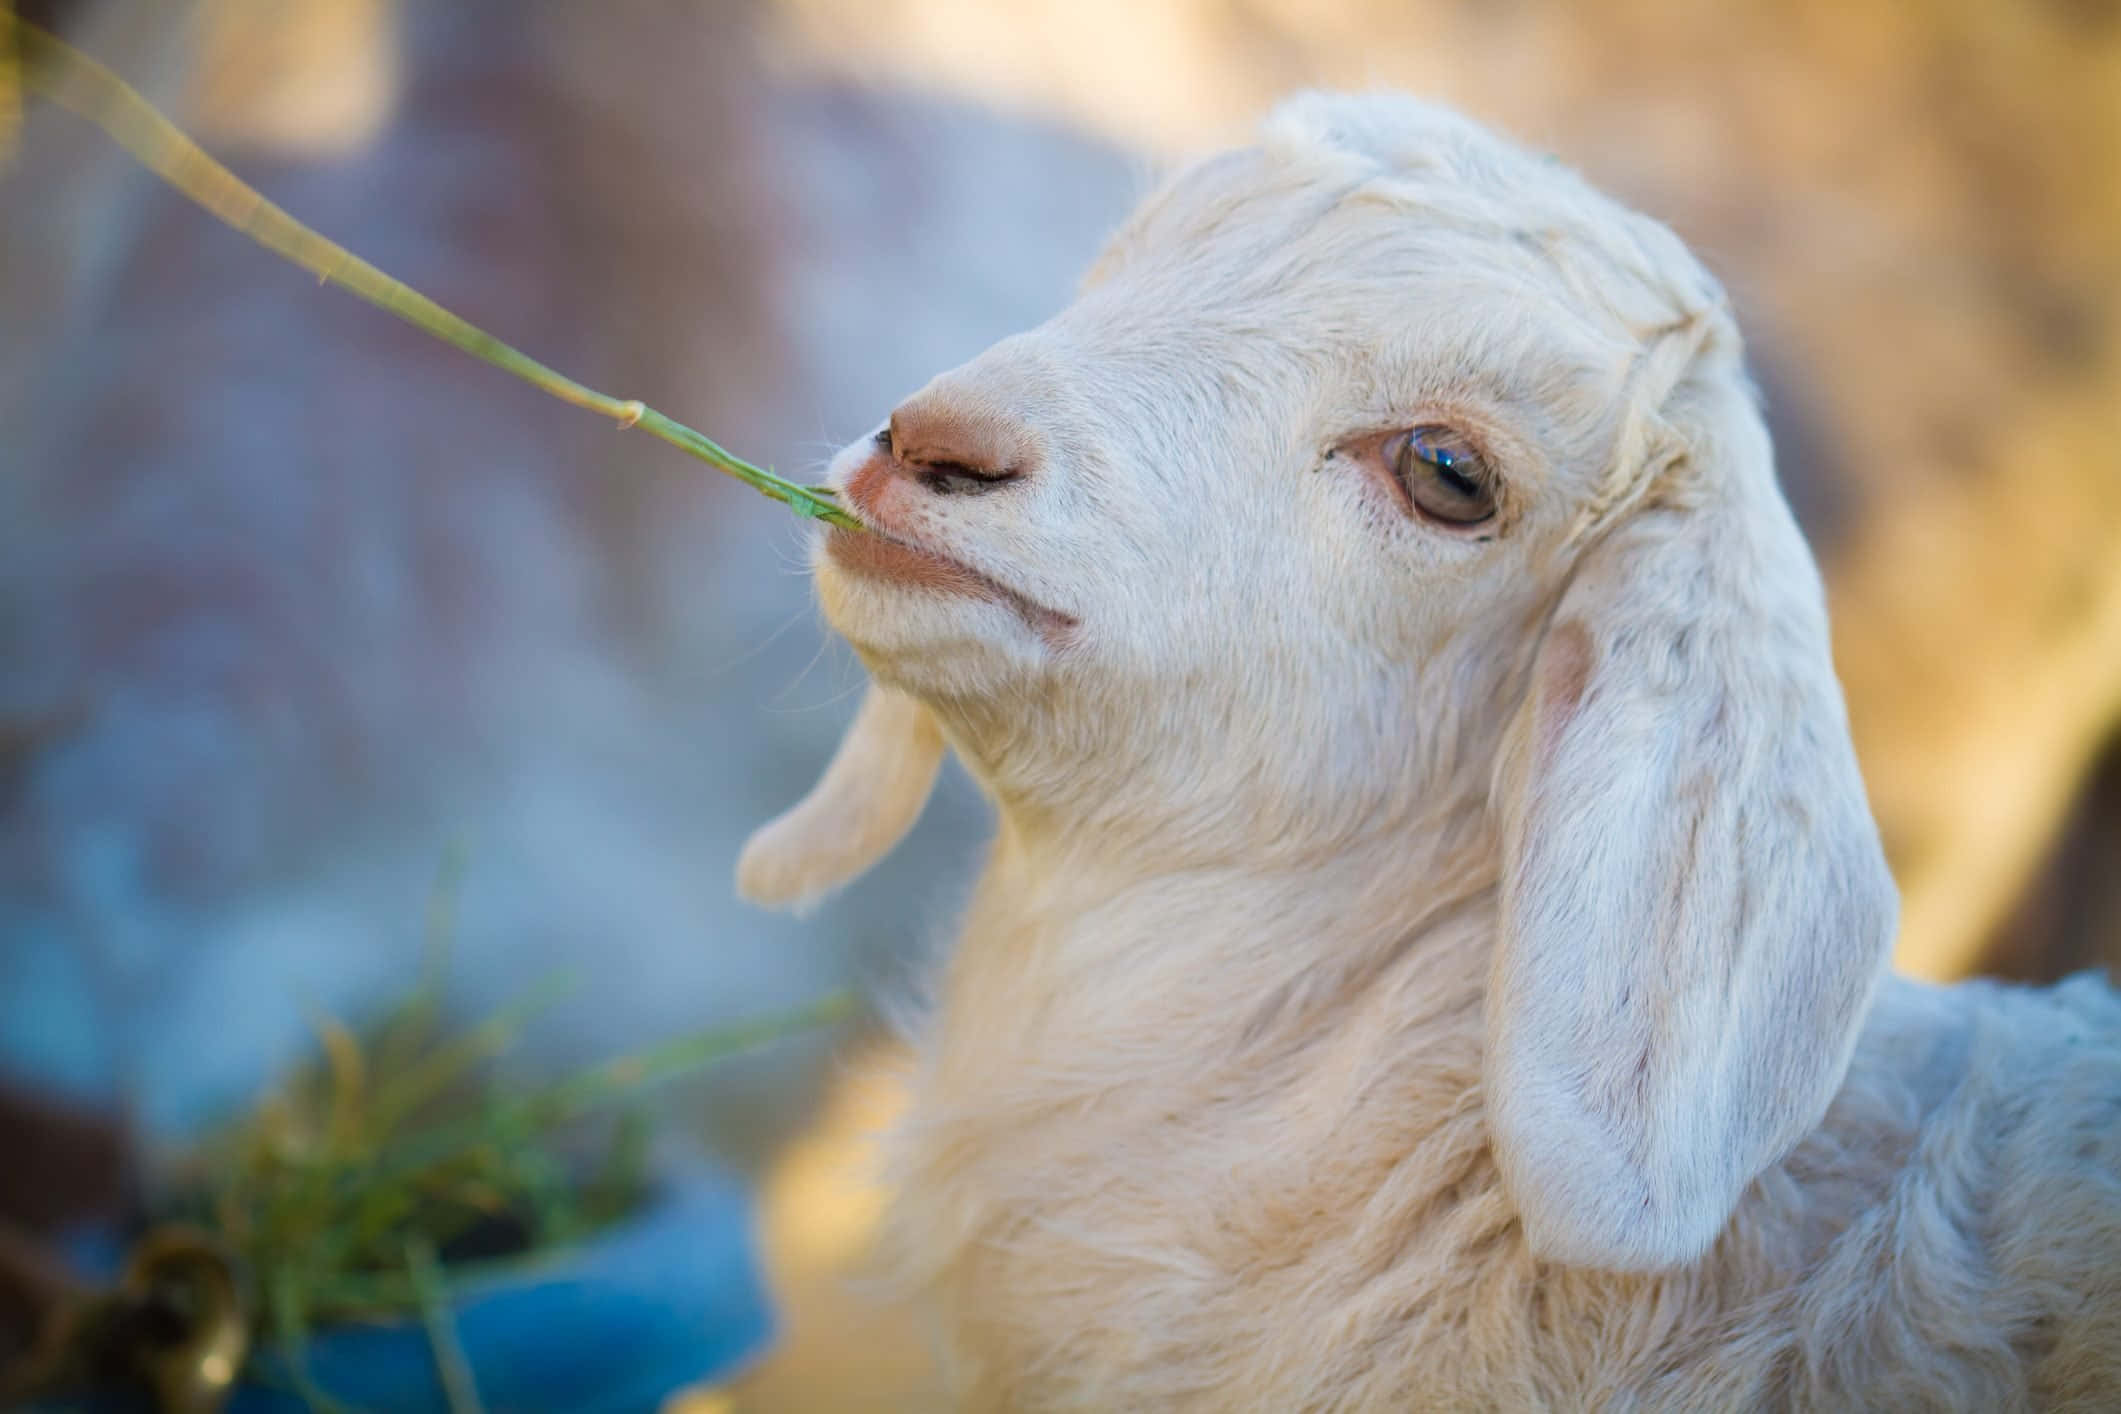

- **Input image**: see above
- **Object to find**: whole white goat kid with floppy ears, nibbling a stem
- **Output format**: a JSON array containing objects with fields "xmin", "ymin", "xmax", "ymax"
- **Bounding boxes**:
[{"xmin": 740, "ymin": 98, "xmax": 2121, "ymax": 1410}]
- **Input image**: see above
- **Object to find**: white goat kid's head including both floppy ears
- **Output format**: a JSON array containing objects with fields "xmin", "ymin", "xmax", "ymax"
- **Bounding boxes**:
[{"xmin": 742, "ymin": 98, "xmax": 1894, "ymax": 1268}]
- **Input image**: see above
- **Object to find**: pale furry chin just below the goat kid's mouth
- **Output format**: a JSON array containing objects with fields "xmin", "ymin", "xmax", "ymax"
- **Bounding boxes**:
[{"xmin": 817, "ymin": 560, "xmax": 1052, "ymax": 702}]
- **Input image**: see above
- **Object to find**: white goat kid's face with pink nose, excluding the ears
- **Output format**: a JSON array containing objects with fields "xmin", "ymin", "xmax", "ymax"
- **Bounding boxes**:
[{"xmin": 817, "ymin": 100, "xmax": 1705, "ymax": 850}]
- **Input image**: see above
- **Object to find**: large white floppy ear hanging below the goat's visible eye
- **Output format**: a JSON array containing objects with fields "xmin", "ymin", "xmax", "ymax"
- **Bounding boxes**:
[{"xmin": 1485, "ymin": 339, "xmax": 1896, "ymax": 1270}]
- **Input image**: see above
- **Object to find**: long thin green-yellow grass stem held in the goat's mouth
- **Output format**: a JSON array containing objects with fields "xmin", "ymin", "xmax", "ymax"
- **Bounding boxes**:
[{"xmin": 14, "ymin": 8, "xmax": 865, "ymax": 530}]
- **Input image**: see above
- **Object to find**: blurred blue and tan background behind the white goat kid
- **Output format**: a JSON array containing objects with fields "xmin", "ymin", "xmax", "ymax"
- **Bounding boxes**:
[{"xmin": 0, "ymin": 0, "xmax": 2121, "ymax": 1410}]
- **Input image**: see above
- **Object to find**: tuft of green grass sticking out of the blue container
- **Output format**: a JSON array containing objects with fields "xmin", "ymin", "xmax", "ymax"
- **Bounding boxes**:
[{"xmin": 154, "ymin": 863, "xmax": 853, "ymax": 1410}]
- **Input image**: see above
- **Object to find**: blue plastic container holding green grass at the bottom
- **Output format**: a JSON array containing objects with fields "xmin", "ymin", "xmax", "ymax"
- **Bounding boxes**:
[{"xmin": 229, "ymin": 1174, "xmax": 774, "ymax": 1414}]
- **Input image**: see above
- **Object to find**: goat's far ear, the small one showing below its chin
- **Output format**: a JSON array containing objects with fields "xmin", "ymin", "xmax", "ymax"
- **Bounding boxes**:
[{"xmin": 736, "ymin": 685, "xmax": 944, "ymax": 909}]
